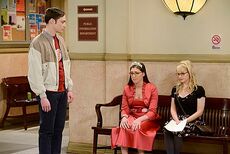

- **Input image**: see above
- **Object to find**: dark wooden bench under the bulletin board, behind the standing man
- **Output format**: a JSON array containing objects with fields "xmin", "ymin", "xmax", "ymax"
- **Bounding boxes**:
[{"xmin": 0, "ymin": 76, "xmax": 38, "ymax": 130}]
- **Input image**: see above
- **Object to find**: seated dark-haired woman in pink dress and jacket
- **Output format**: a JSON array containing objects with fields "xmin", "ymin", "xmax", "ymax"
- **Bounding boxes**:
[{"xmin": 111, "ymin": 62, "xmax": 160, "ymax": 154}]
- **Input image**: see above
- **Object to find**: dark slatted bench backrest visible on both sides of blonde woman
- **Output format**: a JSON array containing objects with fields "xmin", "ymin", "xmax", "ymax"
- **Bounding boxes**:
[{"xmin": 157, "ymin": 95, "xmax": 230, "ymax": 136}]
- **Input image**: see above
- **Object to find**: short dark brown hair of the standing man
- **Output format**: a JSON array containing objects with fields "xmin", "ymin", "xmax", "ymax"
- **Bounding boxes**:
[{"xmin": 45, "ymin": 7, "xmax": 65, "ymax": 24}]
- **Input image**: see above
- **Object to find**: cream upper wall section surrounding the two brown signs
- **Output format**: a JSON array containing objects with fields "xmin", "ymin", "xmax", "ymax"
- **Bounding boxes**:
[{"xmin": 65, "ymin": 0, "xmax": 106, "ymax": 53}]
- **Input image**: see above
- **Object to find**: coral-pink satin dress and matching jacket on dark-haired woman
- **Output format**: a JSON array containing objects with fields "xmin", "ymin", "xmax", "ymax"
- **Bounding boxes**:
[{"xmin": 111, "ymin": 83, "xmax": 159, "ymax": 151}]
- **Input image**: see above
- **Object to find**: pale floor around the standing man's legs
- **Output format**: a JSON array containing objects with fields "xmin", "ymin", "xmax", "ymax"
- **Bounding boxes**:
[{"xmin": 0, "ymin": 121, "xmax": 69, "ymax": 154}]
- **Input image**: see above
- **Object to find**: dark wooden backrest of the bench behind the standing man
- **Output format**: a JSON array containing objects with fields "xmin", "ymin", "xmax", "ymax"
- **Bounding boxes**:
[{"xmin": 2, "ymin": 76, "xmax": 34, "ymax": 103}]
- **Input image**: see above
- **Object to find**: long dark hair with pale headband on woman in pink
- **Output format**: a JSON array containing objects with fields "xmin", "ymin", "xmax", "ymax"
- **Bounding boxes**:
[{"xmin": 128, "ymin": 62, "xmax": 149, "ymax": 86}]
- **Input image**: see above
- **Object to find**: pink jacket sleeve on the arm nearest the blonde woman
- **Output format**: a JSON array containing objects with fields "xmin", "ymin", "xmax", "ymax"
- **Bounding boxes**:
[{"xmin": 146, "ymin": 86, "xmax": 158, "ymax": 120}]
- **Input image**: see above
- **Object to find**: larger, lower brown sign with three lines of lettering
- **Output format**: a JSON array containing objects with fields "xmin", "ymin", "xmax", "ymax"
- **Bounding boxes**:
[{"xmin": 78, "ymin": 17, "xmax": 98, "ymax": 41}]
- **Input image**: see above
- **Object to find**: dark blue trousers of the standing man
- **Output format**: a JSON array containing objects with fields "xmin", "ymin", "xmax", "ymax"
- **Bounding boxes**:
[{"xmin": 39, "ymin": 91, "xmax": 67, "ymax": 154}]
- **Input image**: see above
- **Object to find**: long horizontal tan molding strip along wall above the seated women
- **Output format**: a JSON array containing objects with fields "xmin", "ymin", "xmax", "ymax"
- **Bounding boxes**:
[{"xmin": 70, "ymin": 53, "xmax": 230, "ymax": 63}]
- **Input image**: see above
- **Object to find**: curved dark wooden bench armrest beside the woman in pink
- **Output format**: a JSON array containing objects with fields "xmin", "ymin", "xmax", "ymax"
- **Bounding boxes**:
[{"xmin": 95, "ymin": 95, "xmax": 122, "ymax": 128}]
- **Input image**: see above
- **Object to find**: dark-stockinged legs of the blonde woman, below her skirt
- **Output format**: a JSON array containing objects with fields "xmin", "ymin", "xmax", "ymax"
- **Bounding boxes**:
[{"xmin": 164, "ymin": 130, "xmax": 183, "ymax": 154}]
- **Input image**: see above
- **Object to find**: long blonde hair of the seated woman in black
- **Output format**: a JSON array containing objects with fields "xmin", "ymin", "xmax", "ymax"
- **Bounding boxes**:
[{"xmin": 176, "ymin": 60, "xmax": 197, "ymax": 93}]
